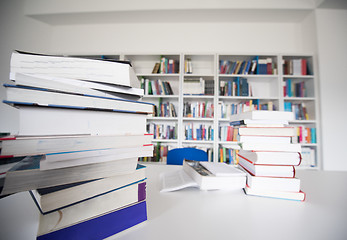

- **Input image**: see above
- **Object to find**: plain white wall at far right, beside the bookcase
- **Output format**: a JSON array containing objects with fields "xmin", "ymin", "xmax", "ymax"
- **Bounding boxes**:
[{"xmin": 316, "ymin": 9, "xmax": 347, "ymax": 171}]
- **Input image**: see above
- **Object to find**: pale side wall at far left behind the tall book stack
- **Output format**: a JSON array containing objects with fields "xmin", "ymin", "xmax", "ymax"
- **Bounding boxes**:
[{"xmin": 0, "ymin": 0, "xmax": 52, "ymax": 132}]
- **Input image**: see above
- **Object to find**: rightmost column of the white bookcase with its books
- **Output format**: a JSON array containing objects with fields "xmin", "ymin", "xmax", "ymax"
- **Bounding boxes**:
[{"xmin": 281, "ymin": 55, "xmax": 321, "ymax": 168}]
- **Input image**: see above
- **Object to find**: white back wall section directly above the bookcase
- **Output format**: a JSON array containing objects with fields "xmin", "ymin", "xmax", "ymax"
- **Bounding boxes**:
[{"xmin": 52, "ymin": 20, "xmax": 303, "ymax": 54}]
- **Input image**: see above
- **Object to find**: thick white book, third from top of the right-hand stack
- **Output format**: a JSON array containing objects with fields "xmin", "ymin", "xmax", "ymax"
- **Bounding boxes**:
[{"xmin": 235, "ymin": 126, "xmax": 295, "ymax": 137}]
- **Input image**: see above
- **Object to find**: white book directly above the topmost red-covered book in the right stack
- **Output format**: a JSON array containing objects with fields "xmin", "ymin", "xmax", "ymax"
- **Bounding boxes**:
[{"xmin": 240, "ymin": 142, "xmax": 301, "ymax": 153}]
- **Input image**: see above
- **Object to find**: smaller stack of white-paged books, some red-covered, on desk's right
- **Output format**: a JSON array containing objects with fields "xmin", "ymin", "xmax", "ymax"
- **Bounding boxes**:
[{"xmin": 230, "ymin": 110, "xmax": 305, "ymax": 201}]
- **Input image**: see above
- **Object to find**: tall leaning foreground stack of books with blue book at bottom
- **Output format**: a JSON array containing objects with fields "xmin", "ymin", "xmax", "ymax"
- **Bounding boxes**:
[{"xmin": 0, "ymin": 51, "xmax": 153, "ymax": 239}]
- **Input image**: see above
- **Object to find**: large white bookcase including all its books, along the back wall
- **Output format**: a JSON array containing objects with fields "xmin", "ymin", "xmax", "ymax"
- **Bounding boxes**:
[{"xmin": 78, "ymin": 53, "xmax": 321, "ymax": 169}]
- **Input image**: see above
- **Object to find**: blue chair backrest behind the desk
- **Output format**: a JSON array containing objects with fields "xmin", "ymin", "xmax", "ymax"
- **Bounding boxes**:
[{"xmin": 166, "ymin": 148, "xmax": 208, "ymax": 165}]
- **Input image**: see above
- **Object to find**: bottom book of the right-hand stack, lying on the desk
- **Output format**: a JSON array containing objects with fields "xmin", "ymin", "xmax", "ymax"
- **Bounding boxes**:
[{"xmin": 244, "ymin": 186, "xmax": 306, "ymax": 202}]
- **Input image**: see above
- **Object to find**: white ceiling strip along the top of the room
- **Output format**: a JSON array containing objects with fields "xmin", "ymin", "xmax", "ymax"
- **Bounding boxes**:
[{"xmin": 25, "ymin": 0, "xmax": 347, "ymax": 26}]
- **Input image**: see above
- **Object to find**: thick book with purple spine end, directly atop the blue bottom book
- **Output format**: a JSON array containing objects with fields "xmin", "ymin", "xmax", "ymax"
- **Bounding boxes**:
[{"xmin": 38, "ymin": 181, "xmax": 146, "ymax": 235}]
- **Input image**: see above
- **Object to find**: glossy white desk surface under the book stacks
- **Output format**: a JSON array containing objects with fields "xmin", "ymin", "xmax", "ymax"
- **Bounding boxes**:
[{"xmin": 0, "ymin": 164, "xmax": 347, "ymax": 240}]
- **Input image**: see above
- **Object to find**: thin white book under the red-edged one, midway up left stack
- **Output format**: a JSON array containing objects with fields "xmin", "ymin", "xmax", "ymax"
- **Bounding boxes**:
[{"xmin": 40, "ymin": 145, "xmax": 154, "ymax": 170}]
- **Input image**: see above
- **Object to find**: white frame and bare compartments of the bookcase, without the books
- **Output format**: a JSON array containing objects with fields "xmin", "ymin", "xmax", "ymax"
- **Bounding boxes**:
[{"xmin": 75, "ymin": 53, "xmax": 321, "ymax": 169}]
